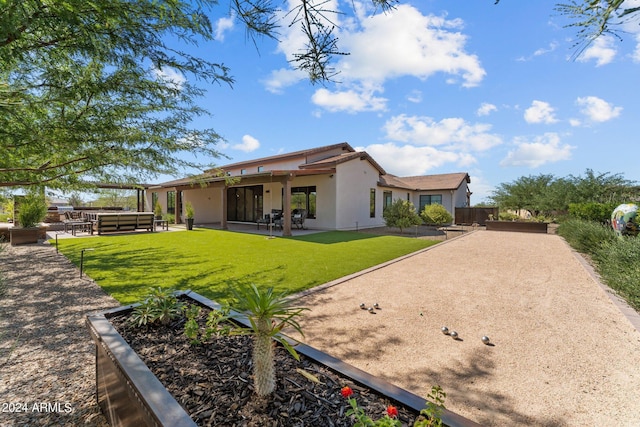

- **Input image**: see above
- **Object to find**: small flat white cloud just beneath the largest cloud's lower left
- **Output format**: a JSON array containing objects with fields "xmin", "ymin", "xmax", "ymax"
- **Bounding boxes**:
[{"xmin": 311, "ymin": 88, "xmax": 387, "ymax": 113}]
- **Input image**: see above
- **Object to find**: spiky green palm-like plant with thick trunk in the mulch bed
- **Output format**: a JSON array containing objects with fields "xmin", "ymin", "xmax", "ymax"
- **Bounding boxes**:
[{"xmin": 230, "ymin": 285, "xmax": 306, "ymax": 396}]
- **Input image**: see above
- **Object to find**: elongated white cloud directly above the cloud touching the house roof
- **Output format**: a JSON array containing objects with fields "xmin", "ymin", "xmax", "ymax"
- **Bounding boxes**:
[{"xmin": 384, "ymin": 114, "xmax": 502, "ymax": 151}]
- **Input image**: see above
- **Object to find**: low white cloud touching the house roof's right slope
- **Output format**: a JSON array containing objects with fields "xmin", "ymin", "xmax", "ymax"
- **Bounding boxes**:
[{"xmin": 358, "ymin": 142, "xmax": 476, "ymax": 176}]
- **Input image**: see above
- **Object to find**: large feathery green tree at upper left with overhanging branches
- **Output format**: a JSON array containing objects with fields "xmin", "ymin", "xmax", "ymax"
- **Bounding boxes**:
[{"xmin": 0, "ymin": 0, "xmax": 396, "ymax": 189}]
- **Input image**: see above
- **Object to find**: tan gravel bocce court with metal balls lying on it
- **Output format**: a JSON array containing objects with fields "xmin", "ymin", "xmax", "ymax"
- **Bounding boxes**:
[{"xmin": 288, "ymin": 231, "xmax": 640, "ymax": 427}]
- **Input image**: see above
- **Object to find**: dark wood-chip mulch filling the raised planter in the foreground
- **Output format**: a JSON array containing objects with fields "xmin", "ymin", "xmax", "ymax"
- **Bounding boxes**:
[{"xmin": 110, "ymin": 304, "xmax": 417, "ymax": 427}]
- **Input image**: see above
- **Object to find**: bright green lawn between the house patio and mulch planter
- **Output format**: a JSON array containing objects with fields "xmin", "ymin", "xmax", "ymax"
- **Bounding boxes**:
[{"xmin": 58, "ymin": 229, "xmax": 438, "ymax": 304}]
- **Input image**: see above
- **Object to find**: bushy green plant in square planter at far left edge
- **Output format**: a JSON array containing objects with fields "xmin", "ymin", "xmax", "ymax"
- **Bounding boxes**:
[{"xmin": 9, "ymin": 192, "xmax": 47, "ymax": 246}]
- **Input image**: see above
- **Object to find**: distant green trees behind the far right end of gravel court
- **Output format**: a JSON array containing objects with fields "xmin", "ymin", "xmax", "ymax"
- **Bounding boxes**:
[{"xmin": 491, "ymin": 169, "xmax": 640, "ymax": 216}]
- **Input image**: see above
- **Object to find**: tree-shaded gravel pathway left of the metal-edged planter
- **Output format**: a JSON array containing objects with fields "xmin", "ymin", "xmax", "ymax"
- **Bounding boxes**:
[{"xmin": 0, "ymin": 244, "xmax": 119, "ymax": 427}]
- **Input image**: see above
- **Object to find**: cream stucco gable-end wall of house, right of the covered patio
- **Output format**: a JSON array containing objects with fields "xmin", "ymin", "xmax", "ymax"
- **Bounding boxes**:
[{"xmin": 335, "ymin": 159, "xmax": 384, "ymax": 230}]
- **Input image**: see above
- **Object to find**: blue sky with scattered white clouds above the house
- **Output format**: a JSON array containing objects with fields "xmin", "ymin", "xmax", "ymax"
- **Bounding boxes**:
[{"xmin": 158, "ymin": 0, "xmax": 640, "ymax": 204}]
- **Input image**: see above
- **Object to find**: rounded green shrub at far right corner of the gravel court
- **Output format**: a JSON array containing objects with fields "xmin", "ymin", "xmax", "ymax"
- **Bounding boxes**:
[{"xmin": 558, "ymin": 219, "xmax": 618, "ymax": 256}]
